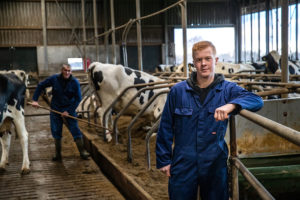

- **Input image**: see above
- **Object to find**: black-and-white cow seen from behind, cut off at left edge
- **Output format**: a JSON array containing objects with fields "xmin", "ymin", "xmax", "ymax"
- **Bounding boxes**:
[{"xmin": 0, "ymin": 73, "xmax": 30, "ymax": 174}]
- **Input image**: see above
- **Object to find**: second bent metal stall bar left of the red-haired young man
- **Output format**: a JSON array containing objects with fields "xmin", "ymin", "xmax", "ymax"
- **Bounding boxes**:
[{"xmin": 127, "ymin": 90, "xmax": 170, "ymax": 162}]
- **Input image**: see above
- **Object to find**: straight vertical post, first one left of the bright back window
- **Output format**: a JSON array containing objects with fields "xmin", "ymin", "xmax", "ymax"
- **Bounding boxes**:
[{"xmin": 135, "ymin": 0, "xmax": 143, "ymax": 71}]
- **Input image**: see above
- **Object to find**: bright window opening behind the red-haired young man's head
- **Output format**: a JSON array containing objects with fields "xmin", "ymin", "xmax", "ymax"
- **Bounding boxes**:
[{"xmin": 174, "ymin": 27, "xmax": 235, "ymax": 65}]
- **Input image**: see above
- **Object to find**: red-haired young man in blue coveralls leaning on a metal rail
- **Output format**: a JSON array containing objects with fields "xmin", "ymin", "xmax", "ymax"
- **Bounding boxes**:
[{"xmin": 156, "ymin": 41, "xmax": 263, "ymax": 200}]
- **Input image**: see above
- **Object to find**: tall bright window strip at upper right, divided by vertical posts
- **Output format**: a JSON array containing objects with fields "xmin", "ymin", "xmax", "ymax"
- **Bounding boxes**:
[{"xmin": 241, "ymin": 3, "xmax": 300, "ymax": 62}]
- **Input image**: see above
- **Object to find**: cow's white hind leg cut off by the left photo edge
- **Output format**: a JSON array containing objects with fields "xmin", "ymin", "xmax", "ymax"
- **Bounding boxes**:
[{"xmin": 0, "ymin": 131, "xmax": 11, "ymax": 171}]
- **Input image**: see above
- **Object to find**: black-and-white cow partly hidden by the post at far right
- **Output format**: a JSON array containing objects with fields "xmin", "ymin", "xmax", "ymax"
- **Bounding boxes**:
[{"xmin": 262, "ymin": 51, "xmax": 300, "ymax": 75}]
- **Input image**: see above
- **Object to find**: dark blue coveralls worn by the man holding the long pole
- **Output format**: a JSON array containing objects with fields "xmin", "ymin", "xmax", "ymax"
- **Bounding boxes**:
[{"xmin": 32, "ymin": 74, "xmax": 82, "ymax": 140}]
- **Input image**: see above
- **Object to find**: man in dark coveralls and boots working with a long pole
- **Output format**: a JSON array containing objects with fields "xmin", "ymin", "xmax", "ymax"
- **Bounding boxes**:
[{"xmin": 32, "ymin": 64, "xmax": 89, "ymax": 161}]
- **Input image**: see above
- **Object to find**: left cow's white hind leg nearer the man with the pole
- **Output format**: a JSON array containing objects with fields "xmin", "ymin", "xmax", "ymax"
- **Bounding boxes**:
[{"xmin": 14, "ymin": 115, "xmax": 30, "ymax": 174}]
